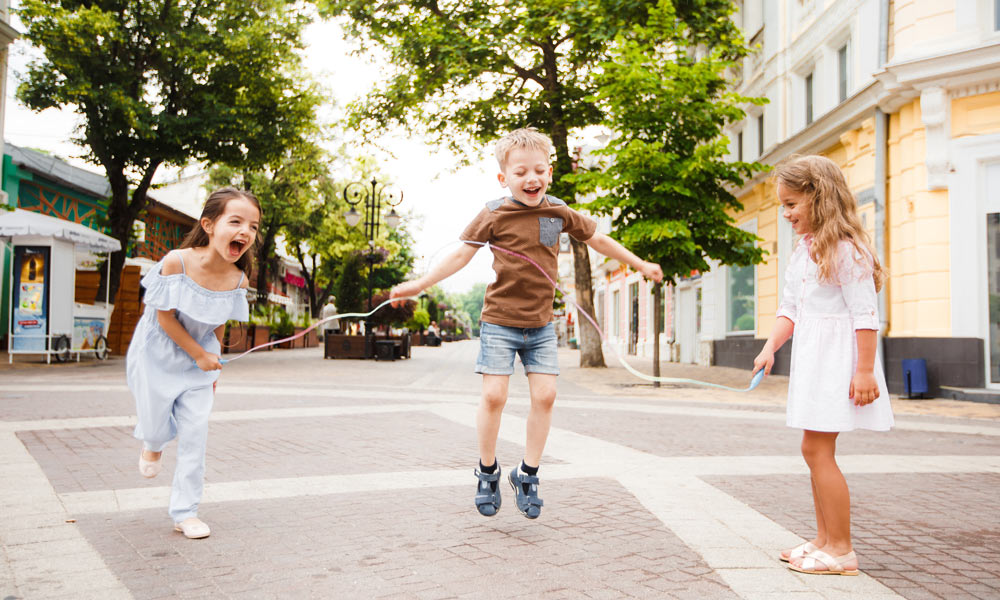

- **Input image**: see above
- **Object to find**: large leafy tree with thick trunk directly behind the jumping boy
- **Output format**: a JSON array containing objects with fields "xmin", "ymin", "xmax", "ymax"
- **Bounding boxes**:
[{"xmin": 319, "ymin": 0, "xmax": 672, "ymax": 366}]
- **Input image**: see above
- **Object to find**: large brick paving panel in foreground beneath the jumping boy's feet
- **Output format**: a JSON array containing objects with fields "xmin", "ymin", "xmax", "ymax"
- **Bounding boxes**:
[{"xmin": 79, "ymin": 477, "xmax": 737, "ymax": 599}]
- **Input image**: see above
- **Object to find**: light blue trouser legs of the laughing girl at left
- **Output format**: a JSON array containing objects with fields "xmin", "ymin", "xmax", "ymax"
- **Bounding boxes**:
[{"xmin": 135, "ymin": 386, "xmax": 215, "ymax": 523}]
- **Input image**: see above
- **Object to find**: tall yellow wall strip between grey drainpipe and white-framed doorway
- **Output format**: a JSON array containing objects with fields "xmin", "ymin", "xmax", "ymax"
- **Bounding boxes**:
[{"xmin": 885, "ymin": 100, "xmax": 951, "ymax": 337}]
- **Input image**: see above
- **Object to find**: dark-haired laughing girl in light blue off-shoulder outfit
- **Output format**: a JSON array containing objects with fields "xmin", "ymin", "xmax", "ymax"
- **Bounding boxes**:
[{"xmin": 126, "ymin": 188, "xmax": 260, "ymax": 538}]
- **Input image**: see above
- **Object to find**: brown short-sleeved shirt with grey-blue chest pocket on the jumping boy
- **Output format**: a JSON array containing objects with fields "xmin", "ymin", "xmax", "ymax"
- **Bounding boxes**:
[{"xmin": 462, "ymin": 196, "xmax": 597, "ymax": 327}]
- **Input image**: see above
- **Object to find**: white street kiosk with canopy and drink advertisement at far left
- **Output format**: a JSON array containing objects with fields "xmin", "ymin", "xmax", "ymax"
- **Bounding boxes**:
[{"xmin": 0, "ymin": 209, "xmax": 121, "ymax": 362}]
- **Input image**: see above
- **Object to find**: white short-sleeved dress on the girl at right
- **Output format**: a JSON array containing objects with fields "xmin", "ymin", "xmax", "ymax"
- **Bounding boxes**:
[{"xmin": 778, "ymin": 236, "xmax": 893, "ymax": 431}]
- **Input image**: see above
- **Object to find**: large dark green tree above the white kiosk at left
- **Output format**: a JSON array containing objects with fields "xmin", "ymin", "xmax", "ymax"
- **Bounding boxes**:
[{"xmin": 17, "ymin": 0, "xmax": 318, "ymax": 297}]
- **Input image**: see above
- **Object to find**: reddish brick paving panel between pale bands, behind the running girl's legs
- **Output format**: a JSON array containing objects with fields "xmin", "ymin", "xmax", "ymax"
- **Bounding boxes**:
[{"xmin": 18, "ymin": 413, "xmax": 562, "ymax": 493}]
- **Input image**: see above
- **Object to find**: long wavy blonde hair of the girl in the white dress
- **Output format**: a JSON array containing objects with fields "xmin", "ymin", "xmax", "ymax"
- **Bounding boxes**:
[{"xmin": 774, "ymin": 155, "xmax": 885, "ymax": 291}]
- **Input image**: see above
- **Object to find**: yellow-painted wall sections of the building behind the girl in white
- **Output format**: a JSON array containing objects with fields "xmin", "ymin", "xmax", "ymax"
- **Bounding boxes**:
[{"xmin": 733, "ymin": 92, "xmax": 1000, "ymax": 337}]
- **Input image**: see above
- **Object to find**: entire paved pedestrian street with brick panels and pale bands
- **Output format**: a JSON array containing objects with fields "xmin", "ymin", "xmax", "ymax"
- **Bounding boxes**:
[{"xmin": 0, "ymin": 342, "xmax": 1000, "ymax": 600}]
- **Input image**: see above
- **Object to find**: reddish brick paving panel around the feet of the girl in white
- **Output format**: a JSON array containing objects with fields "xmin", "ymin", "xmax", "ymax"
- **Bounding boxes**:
[{"xmin": 705, "ymin": 473, "xmax": 1000, "ymax": 600}]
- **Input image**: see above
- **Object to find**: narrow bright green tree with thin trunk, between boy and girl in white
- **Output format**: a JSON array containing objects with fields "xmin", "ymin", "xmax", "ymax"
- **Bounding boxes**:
[{"xmin": 574, "ymin": 0, "xmax": 767, "ymax": 384}]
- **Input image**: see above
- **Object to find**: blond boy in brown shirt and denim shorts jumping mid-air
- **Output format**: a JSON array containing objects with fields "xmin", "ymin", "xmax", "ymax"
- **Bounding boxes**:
[{"xmin": 391, "ymin": 128, "xmax": 663, "ymax": 519}]
